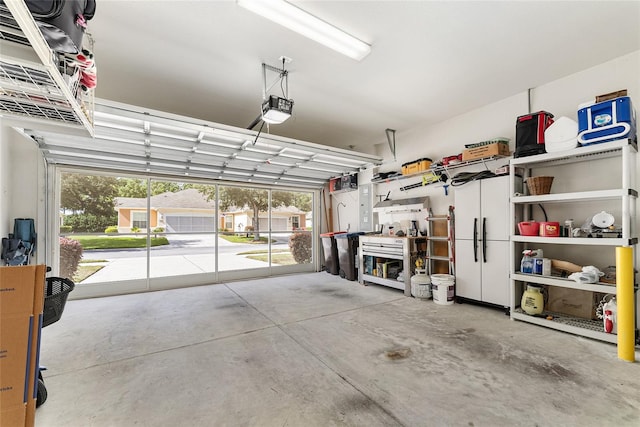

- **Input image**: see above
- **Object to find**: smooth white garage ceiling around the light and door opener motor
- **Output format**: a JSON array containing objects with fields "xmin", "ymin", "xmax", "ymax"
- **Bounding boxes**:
[{"xmin": 89, "ymin": 0, "xmax": 640, "ymax": 152}]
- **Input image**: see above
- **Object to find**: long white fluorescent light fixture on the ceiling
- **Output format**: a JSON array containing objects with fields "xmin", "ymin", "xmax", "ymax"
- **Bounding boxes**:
[{"xmin": 237, "ymin": 0, "xmax": 371, "ymax": 61}]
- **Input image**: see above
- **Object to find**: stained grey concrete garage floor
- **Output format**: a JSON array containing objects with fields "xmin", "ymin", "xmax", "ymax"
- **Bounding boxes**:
[{"xmin": 36, "ymin": 273, "xmax": 640, "ymax": 427}]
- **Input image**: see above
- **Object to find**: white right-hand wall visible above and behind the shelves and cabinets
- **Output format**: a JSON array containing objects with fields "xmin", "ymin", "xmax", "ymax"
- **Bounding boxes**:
[{"xmin": 356, "ymin": 51, "xmax": 640, "ymax": 227}]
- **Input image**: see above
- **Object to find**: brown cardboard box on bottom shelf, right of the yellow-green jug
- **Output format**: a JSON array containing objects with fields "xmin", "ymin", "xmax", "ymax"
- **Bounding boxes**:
[{"xmin": 545, "ymin": 286, "xmax": 602, "ymax": 320}]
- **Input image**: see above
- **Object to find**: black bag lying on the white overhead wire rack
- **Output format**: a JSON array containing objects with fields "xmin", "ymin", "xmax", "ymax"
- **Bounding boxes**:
[{"xmin": 25, "ymin": 0, "xmax": 96, "ymax": 53}]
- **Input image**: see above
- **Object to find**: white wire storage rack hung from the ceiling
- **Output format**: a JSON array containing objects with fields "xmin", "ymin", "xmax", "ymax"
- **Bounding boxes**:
[{"xmin": 0, "ymin": 0, "xmax": 94, "ymax": 136}]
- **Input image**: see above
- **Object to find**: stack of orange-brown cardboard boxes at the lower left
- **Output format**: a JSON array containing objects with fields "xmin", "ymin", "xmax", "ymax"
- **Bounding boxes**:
[{"xmin": 0, "ymin": 265, "xmax": 46, "ymax": 427}]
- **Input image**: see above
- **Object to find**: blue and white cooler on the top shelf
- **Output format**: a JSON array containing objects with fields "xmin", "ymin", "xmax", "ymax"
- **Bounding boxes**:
[{"xmin": 578, "ymin": 96, "xmax": 636, "ymax": 145}]
